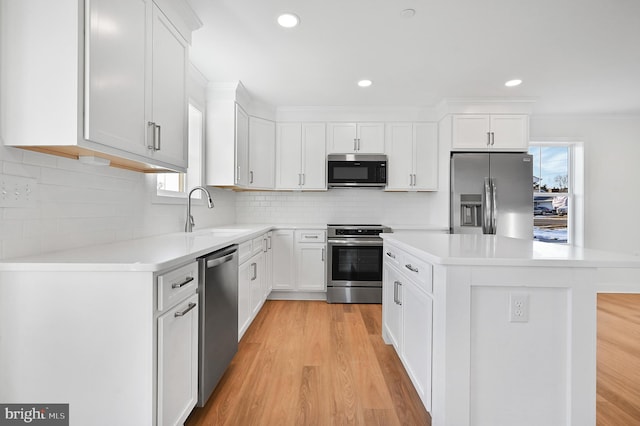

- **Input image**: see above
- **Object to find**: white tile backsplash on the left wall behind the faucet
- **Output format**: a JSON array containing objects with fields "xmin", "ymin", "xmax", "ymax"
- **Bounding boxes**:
[{"xmin": 0, "ymin": 146, "xmax": 235, "ymax": 259}]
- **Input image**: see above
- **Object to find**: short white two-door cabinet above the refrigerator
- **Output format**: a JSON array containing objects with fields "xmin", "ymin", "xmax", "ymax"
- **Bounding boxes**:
[{"xmin": 451, "ymin": 114, "xmax": 529, "ymax": 151}]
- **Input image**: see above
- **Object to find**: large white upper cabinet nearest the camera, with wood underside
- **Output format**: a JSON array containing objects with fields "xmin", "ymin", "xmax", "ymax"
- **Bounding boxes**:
[{"xmin": 0, "ymin": 0, "xmax": 199, "ymax": 171}]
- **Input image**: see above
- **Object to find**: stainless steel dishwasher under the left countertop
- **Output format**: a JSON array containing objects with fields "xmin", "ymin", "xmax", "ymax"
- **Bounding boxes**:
[{"xmin": 198, "ymin": 245, "xmax": 238, "ymax": 407}]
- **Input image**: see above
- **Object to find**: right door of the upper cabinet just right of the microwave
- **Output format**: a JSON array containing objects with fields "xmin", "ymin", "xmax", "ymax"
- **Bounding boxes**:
[{"xmin": 411, "ymin": 123, "xmax": 438, "ymax": 191}]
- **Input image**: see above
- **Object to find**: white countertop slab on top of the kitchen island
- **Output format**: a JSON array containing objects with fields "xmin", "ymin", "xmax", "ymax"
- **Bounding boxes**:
[{"xmin": 382, "ymin": 231, "xmax": 640, "ymax": 268}]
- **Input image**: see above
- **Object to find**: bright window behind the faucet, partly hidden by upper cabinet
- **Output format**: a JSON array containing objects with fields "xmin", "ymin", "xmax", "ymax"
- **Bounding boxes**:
[{"xmin": 156, "ymin": 104, "xmax": 204, "ymax": 198}]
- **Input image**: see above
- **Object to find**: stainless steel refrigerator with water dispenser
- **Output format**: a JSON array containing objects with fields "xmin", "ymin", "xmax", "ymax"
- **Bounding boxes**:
[{"xmin": 450, "ymin": 153, "xmax": 533, "ymax": 239}]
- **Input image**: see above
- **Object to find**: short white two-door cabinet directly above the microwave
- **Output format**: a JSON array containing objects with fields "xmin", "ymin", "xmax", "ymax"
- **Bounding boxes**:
[{"xmin": 327, "ymin": 123, "xmax": 384, "ymax": 154}]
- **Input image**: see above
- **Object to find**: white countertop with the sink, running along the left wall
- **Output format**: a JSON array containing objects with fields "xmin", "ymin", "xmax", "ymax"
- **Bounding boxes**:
[{"xmin": 0, "ymin": 224, "xmax": 326, "ymax": 272}]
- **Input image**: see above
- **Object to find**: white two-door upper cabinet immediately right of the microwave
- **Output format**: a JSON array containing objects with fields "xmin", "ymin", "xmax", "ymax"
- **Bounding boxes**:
[{"xmin": 385, "ymin": 123, "xmax": 438, "ymax": 191}]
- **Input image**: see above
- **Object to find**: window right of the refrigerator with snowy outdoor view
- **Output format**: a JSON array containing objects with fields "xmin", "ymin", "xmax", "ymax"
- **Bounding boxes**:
[{"xmin": 529, "ymin": 142, "xmax": 583, "ymax": 245}]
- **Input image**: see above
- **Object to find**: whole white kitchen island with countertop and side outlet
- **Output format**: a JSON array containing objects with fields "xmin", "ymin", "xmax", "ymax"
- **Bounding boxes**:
[{"xmin": 383, "ymin": 232, "xmax": 640, "ymax": 426}]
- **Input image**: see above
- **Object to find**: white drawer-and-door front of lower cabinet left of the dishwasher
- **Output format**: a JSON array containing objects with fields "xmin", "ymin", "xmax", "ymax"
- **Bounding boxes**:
[{"xmin": 157, "ymin": 262, "xmax": 199, "ymax": 426}]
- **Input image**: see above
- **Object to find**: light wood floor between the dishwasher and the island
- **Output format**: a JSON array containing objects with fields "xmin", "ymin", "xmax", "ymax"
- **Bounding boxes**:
[{"xmin": 185, "ymin": 301, "xmax": 431, "ymax": 426}]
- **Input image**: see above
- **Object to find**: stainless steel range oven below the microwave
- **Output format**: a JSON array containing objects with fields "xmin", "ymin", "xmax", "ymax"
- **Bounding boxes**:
[{"xmin": 327, "ymin": 225, "xmax": 391, "ymax": 303}]
